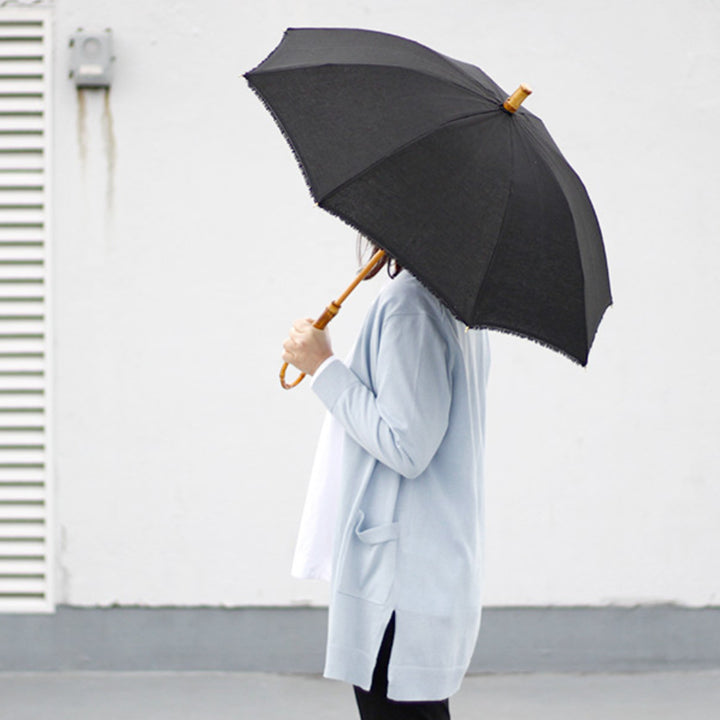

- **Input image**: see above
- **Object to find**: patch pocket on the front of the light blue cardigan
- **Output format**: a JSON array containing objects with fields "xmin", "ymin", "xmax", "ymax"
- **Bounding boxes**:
[{"xmin": 337, "ymin": 510, "xmax": 399, "ymax": 604}]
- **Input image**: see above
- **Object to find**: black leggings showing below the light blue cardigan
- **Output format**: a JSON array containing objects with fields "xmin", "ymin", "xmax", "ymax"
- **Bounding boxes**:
[{"xmin": 354, "ymin": 613, "xmax": 450, "ymax": 720}]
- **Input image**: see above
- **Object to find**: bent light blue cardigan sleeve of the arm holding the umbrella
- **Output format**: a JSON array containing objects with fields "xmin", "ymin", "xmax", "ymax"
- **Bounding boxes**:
[{"xmin": 313, "ymin": 313, "xmax": 452, "ymax": 478}]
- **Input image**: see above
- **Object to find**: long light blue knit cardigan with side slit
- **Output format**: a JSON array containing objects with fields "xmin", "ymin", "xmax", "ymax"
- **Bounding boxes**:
[{"xmin": 313, "ymin": 271, "xmax": 489, "ymax": 700}]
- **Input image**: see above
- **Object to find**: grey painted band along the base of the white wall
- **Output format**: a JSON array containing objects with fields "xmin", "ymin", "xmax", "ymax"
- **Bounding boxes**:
[{"xmin": 0, "ymin": 605, "xmax": 720, "ymax": 673}]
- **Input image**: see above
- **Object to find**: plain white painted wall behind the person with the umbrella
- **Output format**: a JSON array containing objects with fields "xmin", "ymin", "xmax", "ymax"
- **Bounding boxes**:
[{"xmin": 54, "ymin": 0, "xmax": 720, "ymax": 606}]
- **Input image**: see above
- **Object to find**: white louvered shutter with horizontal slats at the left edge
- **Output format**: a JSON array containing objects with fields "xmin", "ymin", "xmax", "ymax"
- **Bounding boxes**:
[{"xmin": 0, "ymin": 7, "xmax": 53, "ymax": 612}]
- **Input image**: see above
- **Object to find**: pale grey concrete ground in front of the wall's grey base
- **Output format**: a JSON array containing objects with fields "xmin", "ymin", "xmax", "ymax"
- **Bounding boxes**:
[{"xmin": 0, "ymin": 670, "xmax": 720, "ymax": 720}]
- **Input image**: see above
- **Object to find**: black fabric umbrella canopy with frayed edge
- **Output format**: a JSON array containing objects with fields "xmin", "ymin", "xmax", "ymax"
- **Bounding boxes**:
[{"xmin": 245, "ymin": 29, "xmax": 611, "ymax": 365}]
